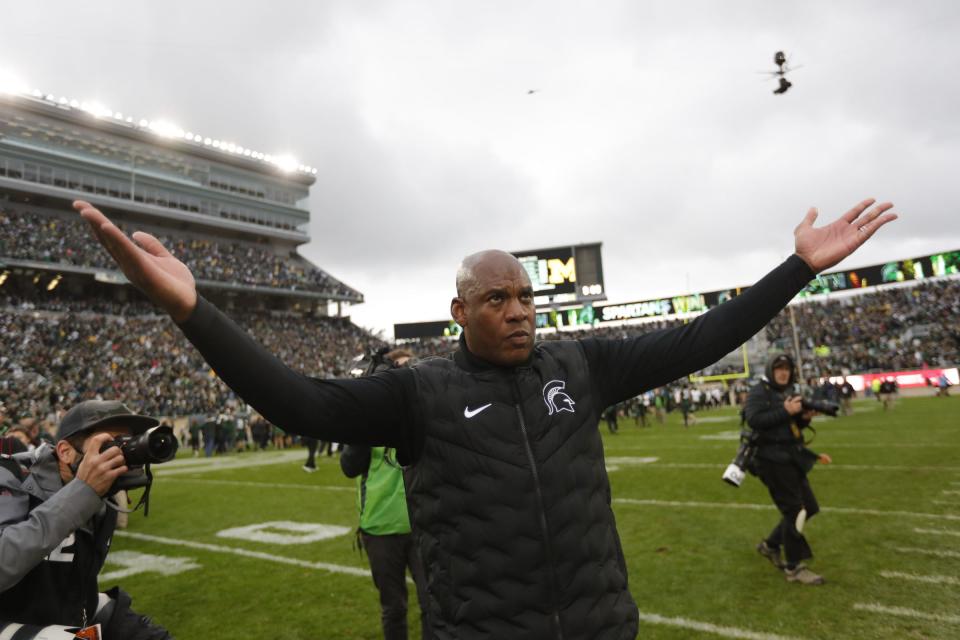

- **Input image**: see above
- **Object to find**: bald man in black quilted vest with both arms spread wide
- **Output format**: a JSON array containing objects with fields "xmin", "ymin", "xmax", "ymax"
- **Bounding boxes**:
[{"xmin": 74, "ymin": 200, "xmax": 896, "ymax": 640}]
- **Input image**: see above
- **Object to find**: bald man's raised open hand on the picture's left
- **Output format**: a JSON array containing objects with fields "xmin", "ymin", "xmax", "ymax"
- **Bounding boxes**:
[{"xmin": 73, "ymin": 200, "xmax": 197, "ymax": 323}]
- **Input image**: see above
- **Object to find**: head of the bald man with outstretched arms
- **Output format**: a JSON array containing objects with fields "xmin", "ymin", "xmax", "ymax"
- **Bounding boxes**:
[{"xmin": 450, "ymin": 249, "xmax": 536, "ymax": 366}]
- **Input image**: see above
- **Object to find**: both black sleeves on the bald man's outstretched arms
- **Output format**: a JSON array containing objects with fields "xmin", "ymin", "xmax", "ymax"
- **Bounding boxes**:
[{"xmin": 181, "ymin": 255, "xmax": 814, "ymax": 462}]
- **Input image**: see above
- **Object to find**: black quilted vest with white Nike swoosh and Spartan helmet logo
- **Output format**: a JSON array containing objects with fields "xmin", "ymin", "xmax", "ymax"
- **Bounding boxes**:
[{"xmin": 405, "ymin": 342, "xmax": 638, "ymax": 640}]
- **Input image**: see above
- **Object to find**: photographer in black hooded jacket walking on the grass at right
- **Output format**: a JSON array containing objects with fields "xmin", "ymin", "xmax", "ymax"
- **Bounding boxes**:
[{"xmin": 744, "ymin": 355, "xmax": 831, "ymax": 585}]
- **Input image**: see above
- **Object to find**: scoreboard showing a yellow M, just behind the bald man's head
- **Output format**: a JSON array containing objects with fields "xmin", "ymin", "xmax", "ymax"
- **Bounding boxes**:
[{"xmin": 513, "ymin": 242, "xmax": 607, "ymax": 307}]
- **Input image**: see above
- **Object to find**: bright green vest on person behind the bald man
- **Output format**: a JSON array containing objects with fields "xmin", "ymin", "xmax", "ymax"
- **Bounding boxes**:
[{"xmin": 357, "ymin": 447, "xmax": 410, "ymax": 536}]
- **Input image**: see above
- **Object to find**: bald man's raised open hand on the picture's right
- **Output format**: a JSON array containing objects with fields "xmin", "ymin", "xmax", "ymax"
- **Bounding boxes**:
[{"xmin": 793, "ymin": 198, "xmax": 897, "ymax": 273}]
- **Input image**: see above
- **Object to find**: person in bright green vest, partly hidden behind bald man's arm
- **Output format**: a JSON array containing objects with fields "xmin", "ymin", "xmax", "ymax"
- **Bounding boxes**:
[{"xmin": 340, "ymin": 349, "xmax": 432, "ymax": 640}]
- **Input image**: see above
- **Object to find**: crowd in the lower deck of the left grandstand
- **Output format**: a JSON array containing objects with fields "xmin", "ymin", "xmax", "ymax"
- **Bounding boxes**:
[{"xmin": 0, "ymin": 298, "xmax": 379, "ymax": 430}]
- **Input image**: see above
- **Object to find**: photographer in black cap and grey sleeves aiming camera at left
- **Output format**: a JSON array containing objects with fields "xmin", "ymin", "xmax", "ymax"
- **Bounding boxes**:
[{"xmin": 0, "ymin": 400, "xmax": 176, "ymax": 640}]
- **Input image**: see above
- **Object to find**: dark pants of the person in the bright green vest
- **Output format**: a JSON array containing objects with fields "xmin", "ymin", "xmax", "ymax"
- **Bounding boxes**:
[{"xmin": 361, "ymin": 532, "xmax": 431, "ymax": 640}]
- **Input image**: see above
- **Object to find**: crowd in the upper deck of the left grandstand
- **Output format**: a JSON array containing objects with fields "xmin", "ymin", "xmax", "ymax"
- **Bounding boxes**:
[{"xmin": 0, "ymin": 210, "xmax": 357, "ymax": 296}]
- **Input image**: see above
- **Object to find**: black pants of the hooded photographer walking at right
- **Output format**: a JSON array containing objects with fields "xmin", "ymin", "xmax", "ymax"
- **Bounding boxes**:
[{"xmin": 757, "ymin": 459, "xmax": 820, "ymax": 567}]
